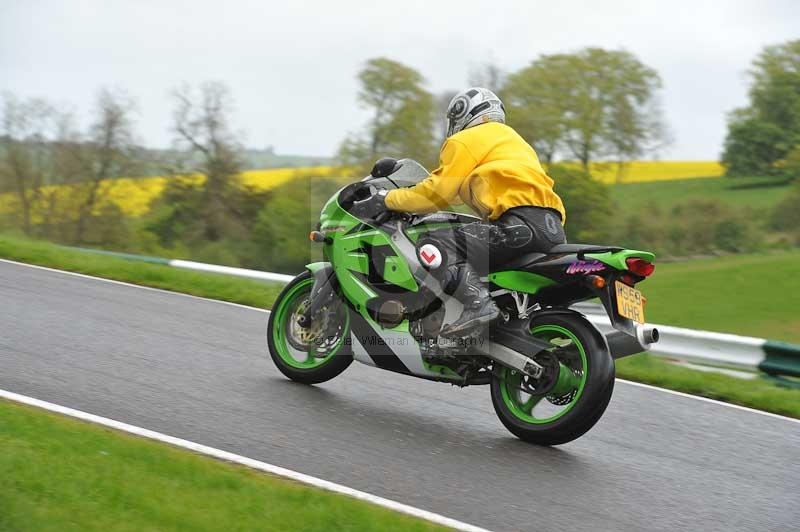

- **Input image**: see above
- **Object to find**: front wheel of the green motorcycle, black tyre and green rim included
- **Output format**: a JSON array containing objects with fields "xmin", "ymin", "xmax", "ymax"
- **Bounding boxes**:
[{"xmin": 267, "ymin": 272, "xmax": 353, "ymax": 384}]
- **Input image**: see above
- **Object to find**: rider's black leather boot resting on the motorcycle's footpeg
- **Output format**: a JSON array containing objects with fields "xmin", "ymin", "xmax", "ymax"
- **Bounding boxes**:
[{"xmin": 441, "ymin": 265, "xmax": 500, "ymax": 338}]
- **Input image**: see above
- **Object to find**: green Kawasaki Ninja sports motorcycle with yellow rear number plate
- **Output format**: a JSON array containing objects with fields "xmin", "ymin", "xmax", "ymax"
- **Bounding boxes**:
[{"xmin": 268, "ymin": 159, "xmax": 658, "ymax": 445}]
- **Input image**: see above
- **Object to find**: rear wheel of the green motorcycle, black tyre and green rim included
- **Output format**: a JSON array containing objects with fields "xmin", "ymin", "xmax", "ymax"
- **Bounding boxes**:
[{"xmin": 491, "ymin": 314, "xmax": 614, "ymax": 445}]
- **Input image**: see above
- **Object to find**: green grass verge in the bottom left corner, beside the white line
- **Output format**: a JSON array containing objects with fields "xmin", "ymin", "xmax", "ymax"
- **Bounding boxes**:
[{"xmin": 0, "ymin": 400, "xmax": 446, "ymax": 532}]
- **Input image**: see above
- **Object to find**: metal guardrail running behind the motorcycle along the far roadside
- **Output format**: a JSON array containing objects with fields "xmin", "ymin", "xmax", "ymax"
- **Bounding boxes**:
[{"xmin": 70, "ymin": 248, "xmax": 800, "ymax": 384}]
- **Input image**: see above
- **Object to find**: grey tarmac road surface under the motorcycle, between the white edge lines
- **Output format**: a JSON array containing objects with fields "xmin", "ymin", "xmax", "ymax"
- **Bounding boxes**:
[{"xmin": 0, "ymin": 262, "xmax": 800, "ymax": 532}]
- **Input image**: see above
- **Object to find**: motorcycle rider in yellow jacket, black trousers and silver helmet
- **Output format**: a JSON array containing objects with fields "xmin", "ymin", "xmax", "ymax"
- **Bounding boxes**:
[{"xmin": 368, "ymin": 87, "xmax": 566, "ymax": 338}]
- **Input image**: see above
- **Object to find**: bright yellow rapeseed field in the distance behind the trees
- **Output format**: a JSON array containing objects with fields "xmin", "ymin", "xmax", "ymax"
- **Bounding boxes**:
[{"xmin": 0, "ymin": 161, "xmax": 724, "ymax": 223}]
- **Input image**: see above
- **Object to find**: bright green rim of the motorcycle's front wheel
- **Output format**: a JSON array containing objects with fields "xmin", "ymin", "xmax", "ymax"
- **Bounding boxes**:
[{"xmin": 272, "ymin": 279, "xmax": 350, "ymax": 369}]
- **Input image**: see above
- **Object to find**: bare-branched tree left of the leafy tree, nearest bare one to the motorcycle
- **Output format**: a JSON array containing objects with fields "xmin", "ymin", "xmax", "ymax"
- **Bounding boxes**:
[{"xmin": 172, "ymin": 82, "xmax": 243, "ymax": 242}]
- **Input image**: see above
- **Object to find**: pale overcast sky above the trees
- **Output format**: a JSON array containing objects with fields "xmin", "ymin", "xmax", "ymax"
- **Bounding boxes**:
[{"xmin": 0, "ymin": 0, "xmax": 800, "ymax": 159}]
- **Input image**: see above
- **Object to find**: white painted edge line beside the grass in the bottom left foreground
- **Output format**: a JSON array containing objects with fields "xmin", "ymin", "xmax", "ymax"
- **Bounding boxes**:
[{"xmin": 0, "ymin": 390, "xmax": 489, "ymax": 532}]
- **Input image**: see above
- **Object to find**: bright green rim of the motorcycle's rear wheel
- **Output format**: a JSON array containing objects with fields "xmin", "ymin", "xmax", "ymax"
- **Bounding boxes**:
[{"xmin": 500, "ymin": 325, "xmax": 588, "ymax": 425}]
